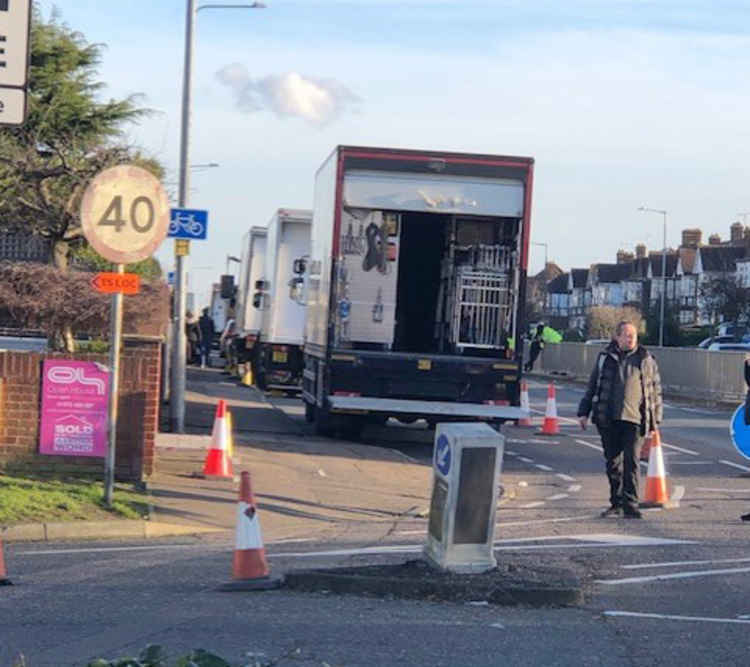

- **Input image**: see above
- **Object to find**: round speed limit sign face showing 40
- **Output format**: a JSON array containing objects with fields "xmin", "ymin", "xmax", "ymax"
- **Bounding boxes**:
[{"xmin": 81, "ymin": 164, "xmax": 169, "ymax": 264}]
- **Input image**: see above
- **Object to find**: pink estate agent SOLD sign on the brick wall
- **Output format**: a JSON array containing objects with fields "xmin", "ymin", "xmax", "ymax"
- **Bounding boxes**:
[{"xmin": 39, "ymin": 359, "xmax": 109, "ymax": 457}]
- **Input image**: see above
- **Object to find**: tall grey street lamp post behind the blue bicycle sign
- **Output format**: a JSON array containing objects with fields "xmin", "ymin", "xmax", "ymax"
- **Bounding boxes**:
[{"xmin": 169, "ymin": 0, "xmax": 265, "ymax": 433}]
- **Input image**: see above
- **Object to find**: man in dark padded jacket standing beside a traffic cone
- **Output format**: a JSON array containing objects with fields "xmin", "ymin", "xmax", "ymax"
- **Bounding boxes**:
[{"xmin": 578, "ymin": 322, "xmax": 662, "ymax": 519}]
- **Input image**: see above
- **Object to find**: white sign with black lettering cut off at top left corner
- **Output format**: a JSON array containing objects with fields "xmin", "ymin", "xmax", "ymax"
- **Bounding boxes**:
[{"xmin": 0, "ymin": 0, "xmax": 31, "ymax": 125}]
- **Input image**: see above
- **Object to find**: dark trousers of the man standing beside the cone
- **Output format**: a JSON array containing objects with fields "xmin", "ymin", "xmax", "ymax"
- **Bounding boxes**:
[{"xmin": 599, "ymin": 420, "xmax": 643, "ymax": 511}]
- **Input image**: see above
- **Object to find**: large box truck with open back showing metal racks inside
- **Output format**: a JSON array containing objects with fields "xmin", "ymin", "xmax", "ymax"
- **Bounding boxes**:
[{"xmin": 302, "ymin": 146, "xmax": 534, "ymax": 435}]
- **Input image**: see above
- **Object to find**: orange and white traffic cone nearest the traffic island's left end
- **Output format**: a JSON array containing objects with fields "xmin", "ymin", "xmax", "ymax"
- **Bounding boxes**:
[{"xmin": 221, "ymin": 471, "xmax": 281, "ymax": 591}]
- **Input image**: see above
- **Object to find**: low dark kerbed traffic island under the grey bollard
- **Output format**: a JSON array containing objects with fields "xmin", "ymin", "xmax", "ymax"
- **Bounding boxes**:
[{"xmin": 285, "ymin": 560, "xmax": 583, "ymax": 607}]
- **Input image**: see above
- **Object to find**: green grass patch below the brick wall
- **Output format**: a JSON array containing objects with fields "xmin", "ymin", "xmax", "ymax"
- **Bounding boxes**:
[{"xmin": 0, "ymin": 474, "xmax": 148, "ymax": 525}]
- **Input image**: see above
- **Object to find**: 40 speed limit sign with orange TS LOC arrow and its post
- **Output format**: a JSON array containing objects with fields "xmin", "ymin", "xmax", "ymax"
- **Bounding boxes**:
[{"xmin": 81, "ymin": 165, "xmax": 169, "ymax": 506}]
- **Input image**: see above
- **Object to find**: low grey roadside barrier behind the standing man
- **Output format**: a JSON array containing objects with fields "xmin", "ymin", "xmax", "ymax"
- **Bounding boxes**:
[{"xmin": 537, "ymin": 343, "xmax": 747, "ymax": 403}]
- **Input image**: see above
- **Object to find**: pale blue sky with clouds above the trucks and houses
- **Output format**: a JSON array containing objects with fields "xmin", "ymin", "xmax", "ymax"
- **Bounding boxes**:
[{"xmin": 39, "ymin": 0, "xmax": 750, "ymax": 308}]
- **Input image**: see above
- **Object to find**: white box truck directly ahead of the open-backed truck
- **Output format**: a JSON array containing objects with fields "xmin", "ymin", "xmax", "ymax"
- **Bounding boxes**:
[{"xmin": 253, "ymin": 208, "xmax": 312, "ymax": 389}]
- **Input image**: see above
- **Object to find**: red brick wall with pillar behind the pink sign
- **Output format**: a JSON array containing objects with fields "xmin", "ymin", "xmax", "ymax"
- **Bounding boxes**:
[{"xmin": 0, "ymin": 336, "xmax": 161, "ymax": 481}]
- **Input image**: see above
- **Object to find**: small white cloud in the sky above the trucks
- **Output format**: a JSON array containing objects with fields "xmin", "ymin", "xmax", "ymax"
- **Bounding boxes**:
[{"xmin": 216, "ymin": 63, "xmax": 360, "ymax": 126}]
